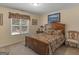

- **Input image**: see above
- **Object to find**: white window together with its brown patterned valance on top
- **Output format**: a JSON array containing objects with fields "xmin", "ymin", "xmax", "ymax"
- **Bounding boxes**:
[{"xmin": 9, "ymin": 12, "xmax": 30, "ymax": 35}]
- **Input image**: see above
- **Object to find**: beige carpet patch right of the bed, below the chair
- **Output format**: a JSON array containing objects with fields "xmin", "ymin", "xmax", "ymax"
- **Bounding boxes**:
[{"xmin": 55, "ymin": 45, "xmax": 79, "ymax": 55}]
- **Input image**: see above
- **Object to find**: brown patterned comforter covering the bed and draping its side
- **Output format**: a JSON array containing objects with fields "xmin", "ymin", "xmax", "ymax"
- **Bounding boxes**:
[{"xmin": 27, "ymin": 31, "xmax": 65, "ymax": 54}]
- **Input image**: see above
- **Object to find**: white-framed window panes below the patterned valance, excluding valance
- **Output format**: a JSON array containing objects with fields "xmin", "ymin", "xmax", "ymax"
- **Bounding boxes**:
[{"xmin": 10, "ymin": 18, "xmax": 29, "ymax": 35}]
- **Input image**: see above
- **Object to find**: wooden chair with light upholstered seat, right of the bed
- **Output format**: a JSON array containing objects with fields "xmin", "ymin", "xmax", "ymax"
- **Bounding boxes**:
[{"xmin": 65, "ymin": 31, "xmax": 79, "ymax": 48}]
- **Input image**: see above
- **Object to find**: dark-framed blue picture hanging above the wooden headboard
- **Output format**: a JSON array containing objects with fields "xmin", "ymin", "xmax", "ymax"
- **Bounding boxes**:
[{"xmin": 48, "ymin": 13, "xmax": 60, "ymax": 24}]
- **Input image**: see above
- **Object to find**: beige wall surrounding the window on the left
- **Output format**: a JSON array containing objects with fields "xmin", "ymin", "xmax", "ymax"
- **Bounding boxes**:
[{"xmin": 0, "ymin": 7, "xmax": 39, "ymax": 47}]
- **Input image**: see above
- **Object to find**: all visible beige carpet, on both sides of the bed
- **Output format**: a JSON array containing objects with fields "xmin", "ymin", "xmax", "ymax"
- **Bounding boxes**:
[{"xmin": 0, "ymin": 42, "xmax": 79, "ymax": 55}]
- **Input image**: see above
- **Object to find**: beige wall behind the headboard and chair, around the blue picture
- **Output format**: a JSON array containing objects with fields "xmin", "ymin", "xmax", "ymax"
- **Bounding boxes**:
[{"xmin": 40, "ymin": 6, "xmax": 79, "ymax": 31}]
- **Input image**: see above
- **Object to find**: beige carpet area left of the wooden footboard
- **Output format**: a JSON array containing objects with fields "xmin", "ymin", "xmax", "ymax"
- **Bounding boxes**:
[{"xmin": 0, "ymin": 42, "xmax": 37, "ymax": 55}]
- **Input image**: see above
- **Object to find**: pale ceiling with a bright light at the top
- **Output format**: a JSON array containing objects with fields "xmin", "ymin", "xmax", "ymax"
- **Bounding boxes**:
[{"xmin": 0, "ymin": 3, "xmax": 79, "ymax": 15}]
